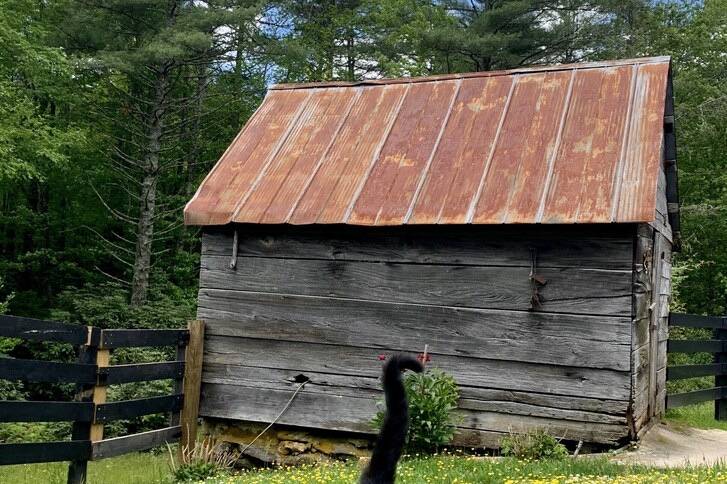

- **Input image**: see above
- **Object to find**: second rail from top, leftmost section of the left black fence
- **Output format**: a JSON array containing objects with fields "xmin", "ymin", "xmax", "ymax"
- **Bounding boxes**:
[{"xmin": 0, "ymin": 358, "xmax": 96, "ymax": 384}]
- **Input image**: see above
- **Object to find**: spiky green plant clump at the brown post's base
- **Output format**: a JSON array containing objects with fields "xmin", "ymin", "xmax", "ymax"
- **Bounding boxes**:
[{"xmin": 167, "ymin": 436, "xmax": 237, "ymax": 482}]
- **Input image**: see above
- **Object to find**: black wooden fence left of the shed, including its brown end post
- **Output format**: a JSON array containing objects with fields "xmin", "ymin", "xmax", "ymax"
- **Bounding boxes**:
[{"xmin": 0, "ymin": 316, "xmax": 203, "ymax": 483}]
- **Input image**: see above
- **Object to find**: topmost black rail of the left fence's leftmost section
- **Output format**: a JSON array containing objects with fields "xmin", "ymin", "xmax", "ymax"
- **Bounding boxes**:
[{"xmin": 0, "ymin": 315, "xmax": 88, "ymax": 345}]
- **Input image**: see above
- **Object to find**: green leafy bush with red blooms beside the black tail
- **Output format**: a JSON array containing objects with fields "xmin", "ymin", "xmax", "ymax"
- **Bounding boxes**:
[{"xmin": 372, "ymin": 369, "xmax": 459, "ymax": 453}]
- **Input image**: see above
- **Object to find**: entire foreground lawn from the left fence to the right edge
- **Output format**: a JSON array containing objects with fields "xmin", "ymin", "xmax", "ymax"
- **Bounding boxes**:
[{"xmin": 0, "ymin": 453, "xmax": 727, "ymax": 484}]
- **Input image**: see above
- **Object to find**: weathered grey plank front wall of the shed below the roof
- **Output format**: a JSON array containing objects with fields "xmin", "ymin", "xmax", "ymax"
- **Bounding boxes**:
[{"xmin": 198, "ymin": 226, "xmax": 635, "ymax": 446}]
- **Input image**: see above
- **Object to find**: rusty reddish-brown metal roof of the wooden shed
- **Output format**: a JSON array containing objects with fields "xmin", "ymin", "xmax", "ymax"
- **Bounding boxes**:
[{"xmin": 184, "ymin": 57, "xmax": 669, "ymax": 225}]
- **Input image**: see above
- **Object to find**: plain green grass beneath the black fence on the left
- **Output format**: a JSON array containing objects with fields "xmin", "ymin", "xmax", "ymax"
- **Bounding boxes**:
[{"xmin": 0, "ymin": 452, "xmax": 170, "ymax": 484}]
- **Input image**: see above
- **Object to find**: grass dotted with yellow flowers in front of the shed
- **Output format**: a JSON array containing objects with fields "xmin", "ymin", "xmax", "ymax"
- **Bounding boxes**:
[{"xmin": 206, "ymin": 455, "xmax": 727, "ymax": 484}]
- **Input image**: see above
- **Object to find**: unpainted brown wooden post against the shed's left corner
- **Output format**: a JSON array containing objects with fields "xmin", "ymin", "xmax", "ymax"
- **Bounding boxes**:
[{"xmin": 179, "ymin": 321, "xmax": 204, "ymax": 460}]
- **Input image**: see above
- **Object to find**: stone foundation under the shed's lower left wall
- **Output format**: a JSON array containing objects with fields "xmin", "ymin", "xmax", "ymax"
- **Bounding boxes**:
[{"xmin": 204, "ymin": 419, "xmax": 373, "ymax": 467}]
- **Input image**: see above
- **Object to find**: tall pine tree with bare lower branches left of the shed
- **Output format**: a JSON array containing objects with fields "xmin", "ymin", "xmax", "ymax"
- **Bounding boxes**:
[{"xmin": 63, "ymin": 0, "xmax": 259, "ymax": 306}]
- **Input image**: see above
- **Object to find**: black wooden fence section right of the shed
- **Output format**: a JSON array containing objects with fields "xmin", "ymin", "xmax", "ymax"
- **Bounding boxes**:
[{"xmin": 666, "ymin": 313, "xmax": 727, "ymax": 420}]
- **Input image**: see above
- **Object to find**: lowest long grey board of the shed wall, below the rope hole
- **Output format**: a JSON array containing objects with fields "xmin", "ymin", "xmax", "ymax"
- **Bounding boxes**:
[{"xmin": 200, "ymin": 383, "xmax": 628, "ymax": 442}]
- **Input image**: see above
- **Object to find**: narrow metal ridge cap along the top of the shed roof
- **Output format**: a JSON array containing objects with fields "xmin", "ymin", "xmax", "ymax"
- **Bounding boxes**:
[{"xmin": 268, "ymin": 56, "xmax": 671, "ymax": 90}]
